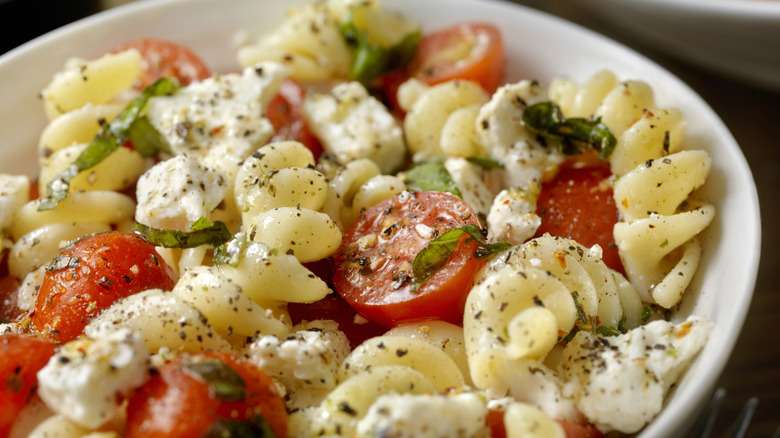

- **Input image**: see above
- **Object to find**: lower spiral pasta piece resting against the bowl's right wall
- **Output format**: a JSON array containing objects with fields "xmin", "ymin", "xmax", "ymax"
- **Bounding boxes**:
[{"xmin": 614, "ymin": 151, "xmax": 715, "ymax": 308}]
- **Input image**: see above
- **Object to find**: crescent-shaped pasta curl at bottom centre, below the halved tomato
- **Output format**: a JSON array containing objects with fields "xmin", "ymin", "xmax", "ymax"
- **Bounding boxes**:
[{"xmin": 339, "ymin": 335, "xmax": 465, "ymax": 392}]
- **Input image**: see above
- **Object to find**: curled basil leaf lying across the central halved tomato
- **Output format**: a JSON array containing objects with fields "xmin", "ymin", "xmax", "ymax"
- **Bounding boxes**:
[{"xmin": 411, "ymin": 224, "xmax": 512, "ymax": 292}]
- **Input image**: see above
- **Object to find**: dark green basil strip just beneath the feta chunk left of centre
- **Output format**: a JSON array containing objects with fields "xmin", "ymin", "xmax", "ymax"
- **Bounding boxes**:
[{"xmin": 135, "ymin": 217, "xmax": 233, "ymax": 248}]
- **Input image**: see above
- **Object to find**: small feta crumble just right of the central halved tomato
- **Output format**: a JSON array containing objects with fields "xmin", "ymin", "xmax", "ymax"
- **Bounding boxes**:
[{"xmin": 487, "ymin": 184, "xmax": 542, "ymax": 245}]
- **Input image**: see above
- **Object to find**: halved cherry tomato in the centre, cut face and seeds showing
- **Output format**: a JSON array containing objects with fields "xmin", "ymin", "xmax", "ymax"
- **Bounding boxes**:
[{"xmin": 333, "ymin": 192, "xmax": 482, "ymax": 327}]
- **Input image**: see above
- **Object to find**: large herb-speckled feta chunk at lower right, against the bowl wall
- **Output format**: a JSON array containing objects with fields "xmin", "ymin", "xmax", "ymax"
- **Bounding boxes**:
[{"xmin": 560, "ymin": 316, "xmax": 712, "ymax": 433}]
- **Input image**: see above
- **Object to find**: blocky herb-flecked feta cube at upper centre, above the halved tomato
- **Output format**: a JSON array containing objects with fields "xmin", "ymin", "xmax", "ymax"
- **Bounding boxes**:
[{"xmin": 303, "ymin": 82, "xmax": 406, "ymax": 174}]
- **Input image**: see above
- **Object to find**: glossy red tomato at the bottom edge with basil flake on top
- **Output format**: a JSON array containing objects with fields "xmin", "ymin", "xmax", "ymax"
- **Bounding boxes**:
[{"xmin": 125, "ymin": 352, "xmax": 287, "ymax": 438}]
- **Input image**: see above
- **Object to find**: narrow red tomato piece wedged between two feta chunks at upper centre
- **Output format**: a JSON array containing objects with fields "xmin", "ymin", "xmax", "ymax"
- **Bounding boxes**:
[{"xmin": 265, "ymin": 79, "xmax": 322, "ymax": 160}]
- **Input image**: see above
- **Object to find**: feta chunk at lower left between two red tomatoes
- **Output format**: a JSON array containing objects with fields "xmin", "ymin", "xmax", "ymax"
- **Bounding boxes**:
[{"xmin": 38, "ymin": 329, "xmax": 149, "ymax": 429}]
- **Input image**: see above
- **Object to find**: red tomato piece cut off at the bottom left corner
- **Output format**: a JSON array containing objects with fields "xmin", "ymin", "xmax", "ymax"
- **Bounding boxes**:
[{"xmin": 0, "ymin": 334, "xmax": 57, "ymax": 437}]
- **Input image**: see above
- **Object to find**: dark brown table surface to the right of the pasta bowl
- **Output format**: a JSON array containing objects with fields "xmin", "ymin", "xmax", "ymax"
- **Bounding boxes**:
[{"xmin": 506, "ymin": 0, "xmax": 780, "ymax": 438}]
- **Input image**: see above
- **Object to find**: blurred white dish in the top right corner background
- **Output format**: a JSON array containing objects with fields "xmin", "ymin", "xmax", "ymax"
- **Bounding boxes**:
[{"xmin": 578, "ymin": 0, "xmax": 780, "ymax": 91}]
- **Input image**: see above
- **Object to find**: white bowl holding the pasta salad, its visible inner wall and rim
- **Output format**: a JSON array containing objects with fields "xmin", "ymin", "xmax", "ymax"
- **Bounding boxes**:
[{"xmin": 0, "ymin": 0, "xmax": 760, "ymax": 437}]
